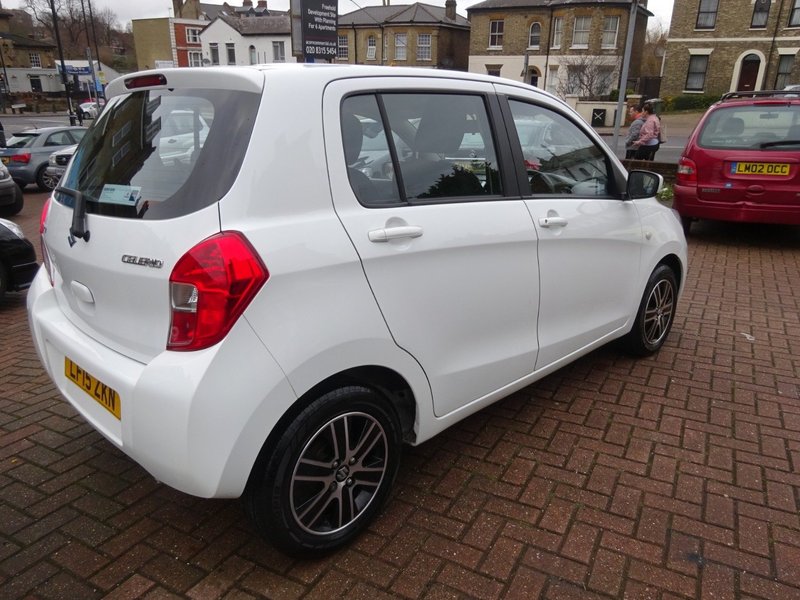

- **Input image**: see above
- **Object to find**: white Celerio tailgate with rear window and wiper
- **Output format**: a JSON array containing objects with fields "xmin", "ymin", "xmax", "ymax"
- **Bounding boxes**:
[{"xmin": 43, "ymin": 69, "xmax": 263, "ymax": 362}]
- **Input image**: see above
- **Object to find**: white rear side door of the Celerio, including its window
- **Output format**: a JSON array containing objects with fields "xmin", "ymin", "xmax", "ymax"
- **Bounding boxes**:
[{"xmin": 323, "ymin": 78, "xmax": 539, "ymax": 416}]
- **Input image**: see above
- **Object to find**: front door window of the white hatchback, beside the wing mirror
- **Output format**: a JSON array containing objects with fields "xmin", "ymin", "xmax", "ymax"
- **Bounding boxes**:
[{"xmin": 509, "ymin": 100, "xmax": 611, "ymax": 198}]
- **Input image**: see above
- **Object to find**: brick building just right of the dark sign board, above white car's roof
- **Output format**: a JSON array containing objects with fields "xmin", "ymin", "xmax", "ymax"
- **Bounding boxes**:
[{"xmin": 336, "ymin": 0, "xmax": 469, "ymax": 71}]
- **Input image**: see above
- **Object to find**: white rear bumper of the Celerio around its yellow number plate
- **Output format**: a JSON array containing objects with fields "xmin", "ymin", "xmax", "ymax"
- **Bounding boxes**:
[{"xmin": 28, "ymin": 270, "xmax": 295, "ymax": 498}]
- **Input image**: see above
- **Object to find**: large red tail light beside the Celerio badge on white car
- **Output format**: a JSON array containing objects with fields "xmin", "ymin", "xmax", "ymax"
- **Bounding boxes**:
[{"xmin": 167, "ymin": 231, "xmax": 269, "ymax": 351}]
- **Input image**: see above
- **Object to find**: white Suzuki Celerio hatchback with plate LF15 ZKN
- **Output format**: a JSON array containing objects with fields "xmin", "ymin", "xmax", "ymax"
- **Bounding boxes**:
[{"xmin": 28, "ymin": 65, "xmax": 686, "ymax": 555}]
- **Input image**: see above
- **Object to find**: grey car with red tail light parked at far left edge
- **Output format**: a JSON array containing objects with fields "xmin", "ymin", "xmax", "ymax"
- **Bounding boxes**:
[{"xmin": 0, "ymin": 127, "xmax": 86, "ymax": 190}]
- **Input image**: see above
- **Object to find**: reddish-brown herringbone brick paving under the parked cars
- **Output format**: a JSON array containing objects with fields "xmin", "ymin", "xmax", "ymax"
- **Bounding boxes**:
[{"xmin": 0, "ymin": 194, "xmax": 800, "ymax": 600}]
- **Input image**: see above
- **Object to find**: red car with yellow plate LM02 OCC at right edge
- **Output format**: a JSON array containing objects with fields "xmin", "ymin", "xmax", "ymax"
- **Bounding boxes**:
[{"xmin": 673, "ymin": 91, "xmax": 800, "ymax": 233}]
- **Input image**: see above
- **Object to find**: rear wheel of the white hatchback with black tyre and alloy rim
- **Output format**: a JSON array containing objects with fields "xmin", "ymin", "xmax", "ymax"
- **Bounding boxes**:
[{"xmin": 242, "ymin": 386, "xmax": 402, "ymax": 557}]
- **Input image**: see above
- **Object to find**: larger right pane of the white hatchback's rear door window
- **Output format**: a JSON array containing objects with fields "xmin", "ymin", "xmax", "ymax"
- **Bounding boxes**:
[{"xmin": 382, "ymin": 93, "xmax": 503, "ymax": 200}]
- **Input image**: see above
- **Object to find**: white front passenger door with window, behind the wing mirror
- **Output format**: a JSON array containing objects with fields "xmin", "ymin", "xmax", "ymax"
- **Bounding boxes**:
[{"xmin": 505, "ymin": 90, "xmax": 642, "ymax": 369}]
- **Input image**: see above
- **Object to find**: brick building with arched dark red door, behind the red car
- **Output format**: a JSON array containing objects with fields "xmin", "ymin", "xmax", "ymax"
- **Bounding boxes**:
[{"xmin": 661, "ymin": 0, "xmax": 800, "ymax": 96}]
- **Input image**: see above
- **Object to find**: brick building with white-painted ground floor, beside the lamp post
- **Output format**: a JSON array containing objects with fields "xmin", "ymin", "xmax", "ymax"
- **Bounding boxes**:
[{"xmin": 467, "ymin": 0, "xmax": 653, "ymax": 96}]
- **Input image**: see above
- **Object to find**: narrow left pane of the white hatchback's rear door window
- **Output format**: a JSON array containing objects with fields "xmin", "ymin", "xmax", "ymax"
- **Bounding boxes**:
[{"xmin": 341, "ymin": 94, "xmax": 408, "ymax": 206}]
